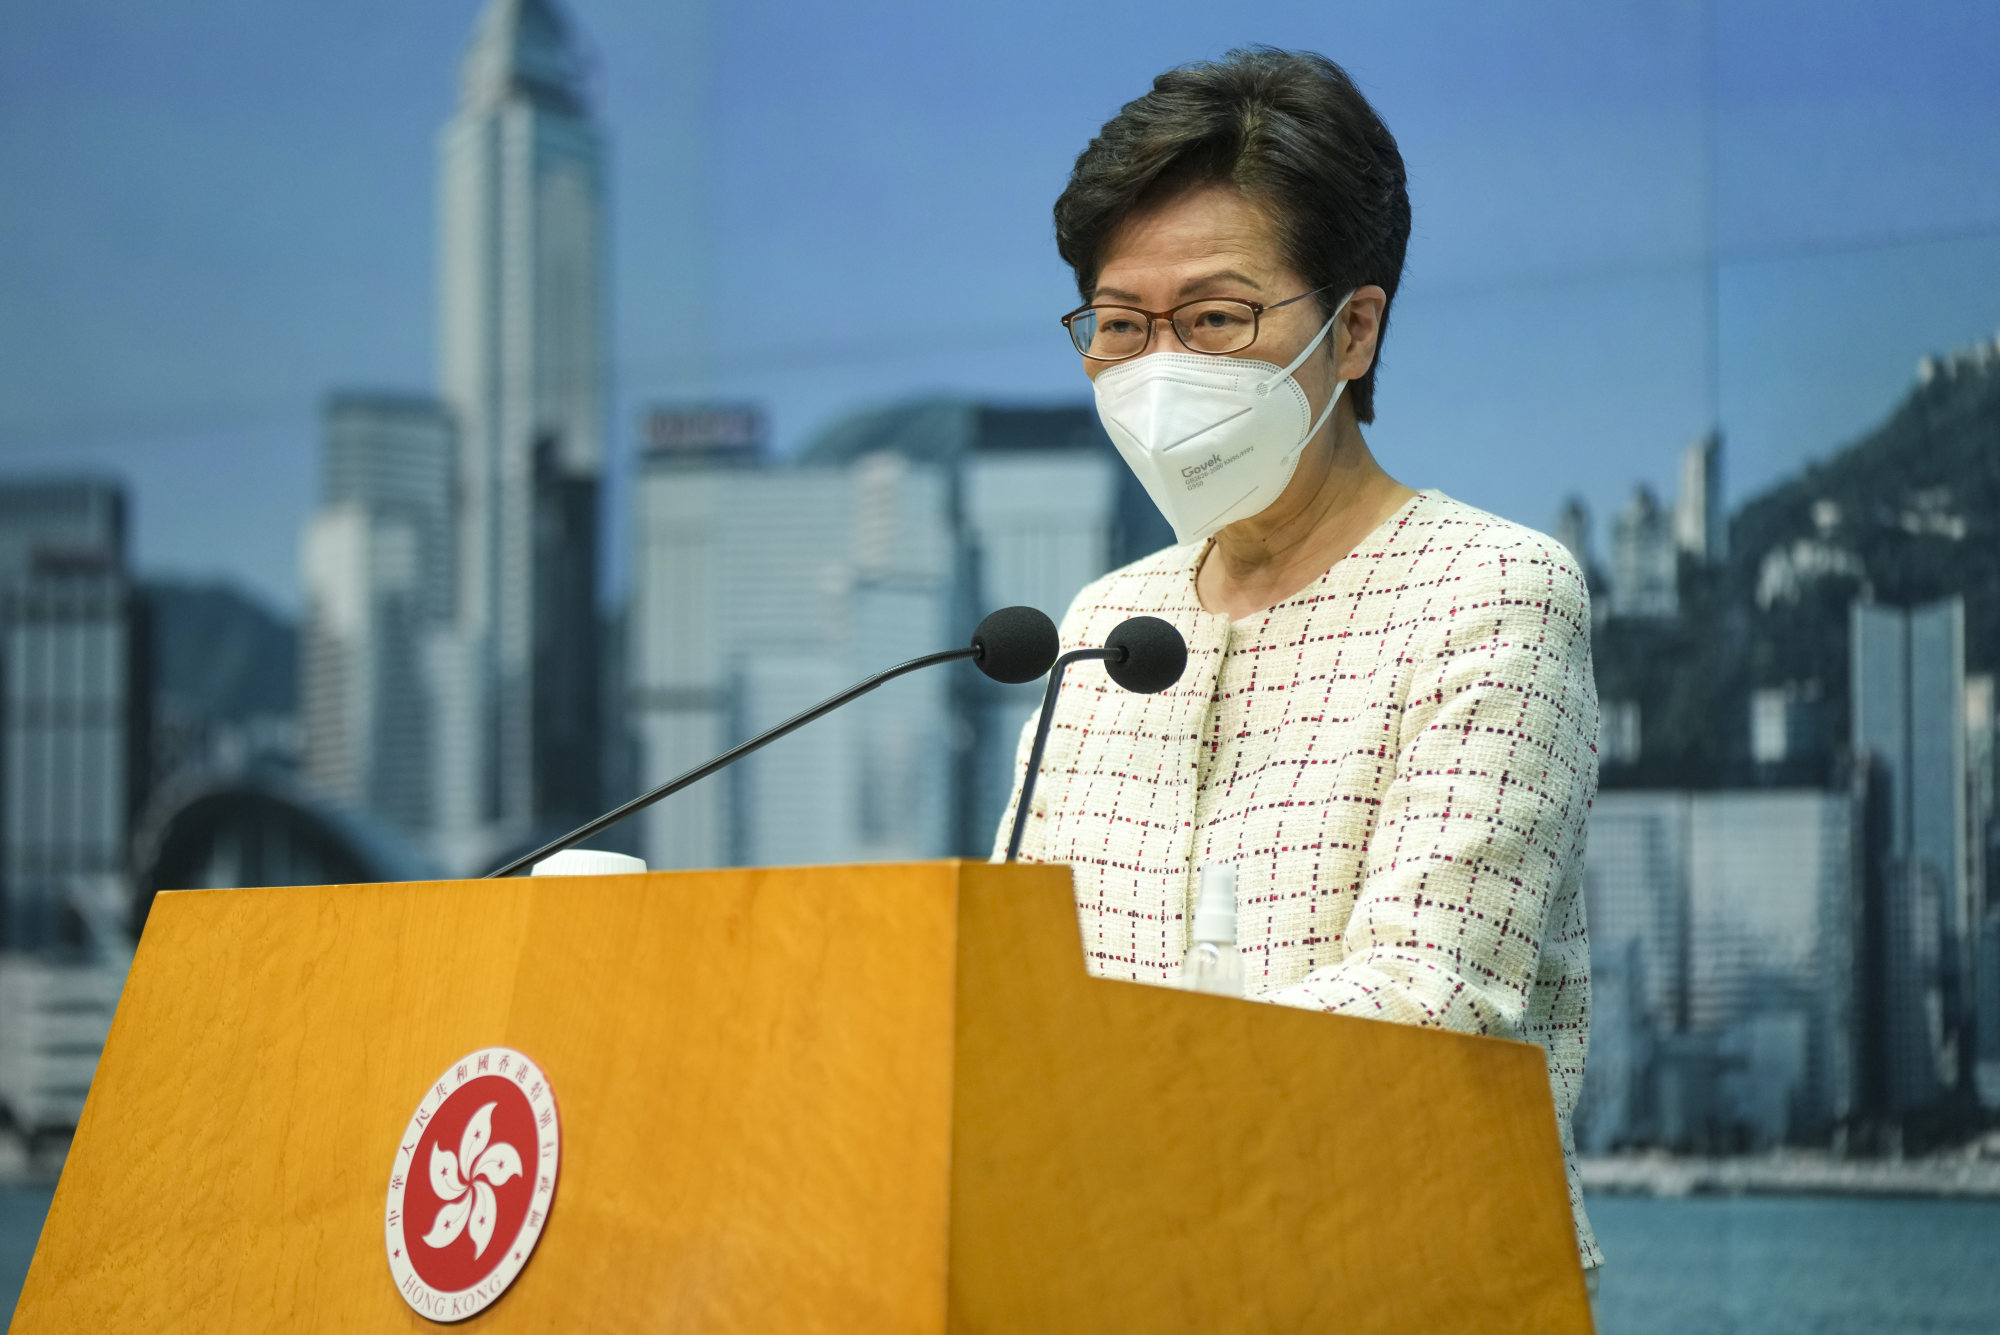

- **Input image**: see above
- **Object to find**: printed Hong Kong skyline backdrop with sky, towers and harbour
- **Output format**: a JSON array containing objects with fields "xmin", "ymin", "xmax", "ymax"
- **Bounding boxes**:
[{"xmin": 0, "ymin": 0, "xmax": 2000, "ymax": 1335}]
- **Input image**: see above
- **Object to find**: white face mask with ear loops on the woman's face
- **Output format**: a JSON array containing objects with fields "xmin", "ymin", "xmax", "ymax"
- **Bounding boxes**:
[{"xmin": 1096, "ymin": 292, "xmax": 1354, "ymax": 544}]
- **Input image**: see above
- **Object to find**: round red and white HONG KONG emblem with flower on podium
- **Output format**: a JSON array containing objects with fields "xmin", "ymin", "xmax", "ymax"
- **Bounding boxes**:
[{"xmin": 384, "ymin": 1047, "xmax": 562, "ymax": 1321}]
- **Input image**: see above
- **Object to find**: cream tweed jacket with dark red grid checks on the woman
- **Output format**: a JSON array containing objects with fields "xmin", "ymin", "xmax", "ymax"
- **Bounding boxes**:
[{"xmin": 996, "ymin": 492, "xmax": 1602, "ymax": 1265}]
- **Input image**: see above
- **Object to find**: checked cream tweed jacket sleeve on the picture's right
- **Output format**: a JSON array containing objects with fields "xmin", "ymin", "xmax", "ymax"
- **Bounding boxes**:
[{"xmin": 1264, "ymin": 544, "xmax": 1598, "ymax": 1037}]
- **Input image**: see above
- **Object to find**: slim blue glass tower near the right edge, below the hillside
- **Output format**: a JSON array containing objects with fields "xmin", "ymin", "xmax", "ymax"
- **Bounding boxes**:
[{"xmin": 1848, "ymin": 598, "xmax": 1976, "ymax": 1119}]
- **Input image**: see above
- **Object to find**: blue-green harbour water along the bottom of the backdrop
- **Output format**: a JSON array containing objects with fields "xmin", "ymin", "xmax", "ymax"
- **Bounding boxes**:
[{"xmin": 0, "ymin": 1187, "xmax": 2000, "ymax": 1335}]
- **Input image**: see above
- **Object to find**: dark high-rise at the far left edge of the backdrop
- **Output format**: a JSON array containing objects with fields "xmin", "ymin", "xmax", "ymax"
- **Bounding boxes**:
[{"xmin": 0, "ymin": 478, "xmax": 133, "ymax": 1131}]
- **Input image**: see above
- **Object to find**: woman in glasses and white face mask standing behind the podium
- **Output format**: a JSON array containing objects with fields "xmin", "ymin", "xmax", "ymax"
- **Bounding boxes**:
[{"xmin": 1000, "ymin": 50, "xmax": 1602, "ymax": 1289}]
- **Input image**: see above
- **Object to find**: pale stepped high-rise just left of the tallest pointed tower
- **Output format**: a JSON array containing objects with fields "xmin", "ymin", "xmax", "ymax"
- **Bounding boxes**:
[{"xmin": 300, "ymin": 394, "xmax": 456, "ymax": 837}]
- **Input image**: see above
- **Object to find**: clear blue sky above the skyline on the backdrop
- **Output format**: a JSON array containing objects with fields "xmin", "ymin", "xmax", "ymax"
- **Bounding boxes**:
[{"xmin": 0, "ymin": 0, "xmax": 2000, "ymax": 606}]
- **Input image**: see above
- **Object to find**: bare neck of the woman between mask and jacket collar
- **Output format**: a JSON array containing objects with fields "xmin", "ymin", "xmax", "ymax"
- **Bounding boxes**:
[{"xmin": 1194, "ymin": 404, "xmax": 1416, "ymax": 620}]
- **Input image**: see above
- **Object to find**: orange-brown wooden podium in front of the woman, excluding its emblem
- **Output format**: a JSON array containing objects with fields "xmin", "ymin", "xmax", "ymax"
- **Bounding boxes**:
[{"xmin": 12, "ymin": 863, "xmax": 1590, "ymax": 1335}]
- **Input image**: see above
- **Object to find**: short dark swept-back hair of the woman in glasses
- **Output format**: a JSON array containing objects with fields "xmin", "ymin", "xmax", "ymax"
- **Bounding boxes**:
[{"xmin": 1056, "ymin": 46, "xmax": 1410, "ymax": 422}]
